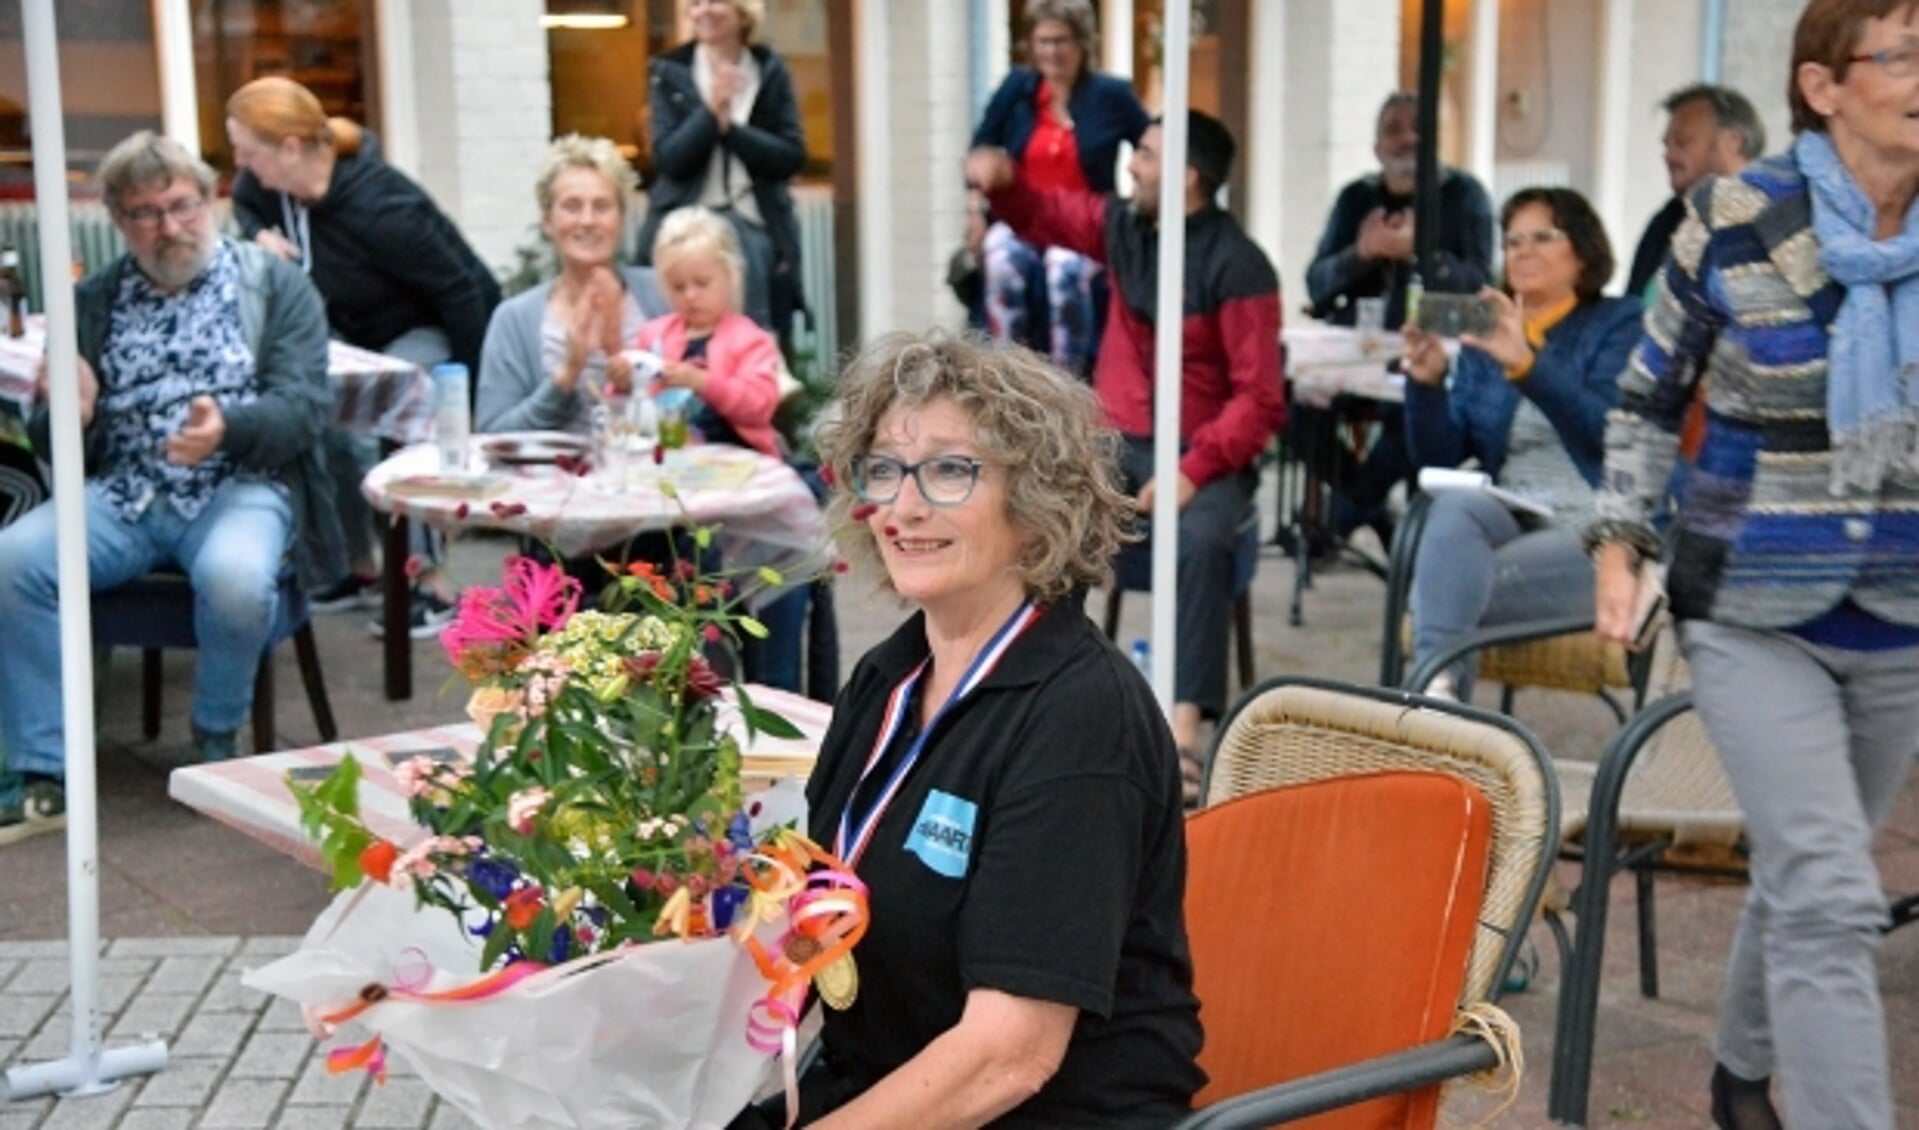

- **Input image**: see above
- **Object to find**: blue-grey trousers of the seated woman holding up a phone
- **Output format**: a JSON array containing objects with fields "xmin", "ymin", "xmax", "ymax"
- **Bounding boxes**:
[{"xmin": 1412, "ymin": 491, "xmax": 1593, "ymax": 698}]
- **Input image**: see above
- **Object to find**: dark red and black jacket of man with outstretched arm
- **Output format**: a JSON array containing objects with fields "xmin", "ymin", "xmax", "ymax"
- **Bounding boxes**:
[{"xmin": 992, "ymin": 184, "xmax": 1286, "ymax": 487}]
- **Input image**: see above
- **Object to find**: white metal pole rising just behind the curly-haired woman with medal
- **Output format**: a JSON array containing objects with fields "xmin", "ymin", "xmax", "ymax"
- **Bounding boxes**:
[{"xmin": 1153, "ymin": 0, "xmax": 1182, "ymax": 716}]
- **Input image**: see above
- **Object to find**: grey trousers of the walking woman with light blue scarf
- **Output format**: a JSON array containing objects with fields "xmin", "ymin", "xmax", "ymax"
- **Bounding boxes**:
[{"xmin": 1679, "ymin": 620, "xmax": 1919, "ymax": 1130}]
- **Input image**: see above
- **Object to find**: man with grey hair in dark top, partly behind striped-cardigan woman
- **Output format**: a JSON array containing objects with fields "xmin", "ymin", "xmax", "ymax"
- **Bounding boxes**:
[{"xmin": 1625, "ymin": 82, "xmax": 1765, "ymax": 297}]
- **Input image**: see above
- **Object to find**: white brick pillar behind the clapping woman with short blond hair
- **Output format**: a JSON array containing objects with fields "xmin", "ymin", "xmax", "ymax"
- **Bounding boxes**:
[{"xmin": 409, "ymin": 0, "xmax": 553, "ymax": 267}]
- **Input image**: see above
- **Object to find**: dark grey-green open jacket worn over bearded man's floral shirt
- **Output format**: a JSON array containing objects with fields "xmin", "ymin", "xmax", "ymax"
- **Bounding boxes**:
[{"xmin": 29, "ymin": 244, "xmax": 347, "ymax": 589}]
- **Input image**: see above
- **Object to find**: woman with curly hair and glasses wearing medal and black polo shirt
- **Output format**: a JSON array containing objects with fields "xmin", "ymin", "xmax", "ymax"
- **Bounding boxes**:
[{"xmin": 737, "ymin": 334, "xmax": 1205, "ymax": 1128}]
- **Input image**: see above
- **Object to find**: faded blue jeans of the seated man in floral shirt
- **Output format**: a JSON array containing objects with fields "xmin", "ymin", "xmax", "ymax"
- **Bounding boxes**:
[{"xmin": 0, "ymin": 480, "xmax": 294, "ymax": 777}]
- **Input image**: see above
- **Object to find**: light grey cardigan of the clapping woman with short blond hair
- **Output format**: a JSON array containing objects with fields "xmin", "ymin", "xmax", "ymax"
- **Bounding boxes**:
[{"xmin": 474, "ymin": 267, "xmax": 668, "ymax": 432}]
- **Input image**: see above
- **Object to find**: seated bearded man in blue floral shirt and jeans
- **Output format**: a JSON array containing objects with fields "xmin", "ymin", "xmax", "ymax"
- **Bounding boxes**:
[{"xmin": 0, "ymin": 130, "xmax": 344, "ymax": 844}]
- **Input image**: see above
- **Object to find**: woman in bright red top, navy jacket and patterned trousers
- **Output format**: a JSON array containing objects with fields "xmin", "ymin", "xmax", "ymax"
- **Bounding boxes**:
[{"xmin": 973, "ymin": 0, "xmax": 1148, "ymax": 374}]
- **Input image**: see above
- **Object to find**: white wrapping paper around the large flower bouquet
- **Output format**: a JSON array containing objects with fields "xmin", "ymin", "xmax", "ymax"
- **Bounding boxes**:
[{"xmin": 244, "ymin": 783, "xmax": 804, "ymax": 1130}]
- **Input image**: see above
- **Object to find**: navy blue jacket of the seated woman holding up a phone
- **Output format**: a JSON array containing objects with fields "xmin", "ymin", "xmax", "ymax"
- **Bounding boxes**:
[{"xmin": 1407, "ymin": 297, "xmax": 1639, "ymax": 487}]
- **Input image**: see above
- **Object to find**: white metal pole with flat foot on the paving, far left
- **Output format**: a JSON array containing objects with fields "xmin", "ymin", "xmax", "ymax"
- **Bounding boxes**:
[{"xmin": 6, "ymin": 0, "xmax": 167, "ymax": 1099}]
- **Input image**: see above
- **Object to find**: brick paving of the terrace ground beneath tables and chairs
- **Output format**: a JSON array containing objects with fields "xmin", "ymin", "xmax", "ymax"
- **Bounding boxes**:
[{"xmin": 0, "ymin": 525, "xmax": 1919, "ymax": 1130}]
